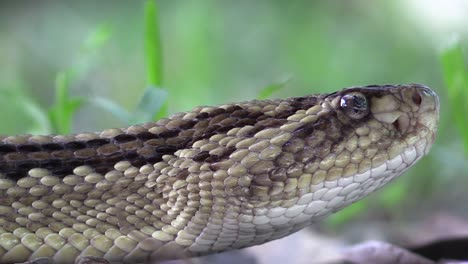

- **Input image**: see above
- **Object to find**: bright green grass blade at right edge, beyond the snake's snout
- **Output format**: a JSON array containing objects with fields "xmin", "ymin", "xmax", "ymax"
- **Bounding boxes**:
[{"xmin": 441, "ymin": 42, "xmax": 468, "ymax": 156}]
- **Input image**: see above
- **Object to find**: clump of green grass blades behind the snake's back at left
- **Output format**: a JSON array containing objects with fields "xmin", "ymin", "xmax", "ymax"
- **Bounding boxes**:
[{"xmin": 1, "ymin": 0, "xmax": 167, "ymax": 134}]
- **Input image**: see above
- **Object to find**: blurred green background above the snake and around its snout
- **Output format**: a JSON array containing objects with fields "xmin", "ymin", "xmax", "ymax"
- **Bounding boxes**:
[{"xmin": 0, "ymin": 0, "xmax": 468, "ymax": 243}]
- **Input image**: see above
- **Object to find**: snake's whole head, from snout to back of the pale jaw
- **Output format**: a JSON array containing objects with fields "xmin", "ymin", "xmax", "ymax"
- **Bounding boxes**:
[{"xmin": 219, "ymin": 84, "xmax": 439, "ymax": 250}]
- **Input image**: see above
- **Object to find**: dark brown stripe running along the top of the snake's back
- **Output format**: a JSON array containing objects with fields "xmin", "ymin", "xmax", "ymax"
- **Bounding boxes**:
[{"xmin": 0, "ymin": 96, "xmax": 318, "ymax": 180}]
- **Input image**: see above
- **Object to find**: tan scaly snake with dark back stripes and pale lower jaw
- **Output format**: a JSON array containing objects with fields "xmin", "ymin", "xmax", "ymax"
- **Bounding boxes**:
[{"xmin": 0, "ymin": 84, "xmax": 439, "ymax": 264}]
